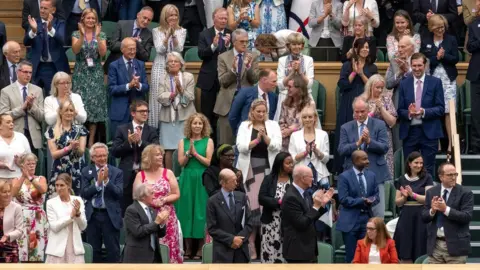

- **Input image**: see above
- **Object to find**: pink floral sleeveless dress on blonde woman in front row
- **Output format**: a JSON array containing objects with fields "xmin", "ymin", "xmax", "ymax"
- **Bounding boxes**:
[{"xmin": 141, "ymin": 169, "xmax": 183, "ymax": 263}]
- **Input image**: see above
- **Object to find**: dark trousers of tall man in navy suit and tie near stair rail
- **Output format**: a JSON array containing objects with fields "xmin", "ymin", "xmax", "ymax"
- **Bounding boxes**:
[{"xmin": 403, "ymin": 125, "xmax": 438, "ymax": 177}]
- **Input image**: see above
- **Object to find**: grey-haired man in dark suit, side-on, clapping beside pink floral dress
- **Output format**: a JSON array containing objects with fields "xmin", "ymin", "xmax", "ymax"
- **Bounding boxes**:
[{"xmin": 122, "ymin": 184, "xmax": 170, "ymax": 263}]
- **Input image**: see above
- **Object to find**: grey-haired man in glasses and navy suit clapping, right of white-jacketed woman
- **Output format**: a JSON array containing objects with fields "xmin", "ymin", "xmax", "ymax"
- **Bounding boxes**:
[{"xmin": 82, "ymin": 143, "xmax": 123, "ymax": 263}]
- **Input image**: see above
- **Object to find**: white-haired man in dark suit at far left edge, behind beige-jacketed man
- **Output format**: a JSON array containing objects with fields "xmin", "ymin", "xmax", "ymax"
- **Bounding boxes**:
[{"xmin": 0, "ymin": 41, "xmax": 21, "ymax": 90}]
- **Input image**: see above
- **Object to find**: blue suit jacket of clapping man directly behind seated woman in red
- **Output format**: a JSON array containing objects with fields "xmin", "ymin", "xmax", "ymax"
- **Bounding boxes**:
[{"xmin": 336, "ymin": 168, "xmax": 380, "ymax": 232}]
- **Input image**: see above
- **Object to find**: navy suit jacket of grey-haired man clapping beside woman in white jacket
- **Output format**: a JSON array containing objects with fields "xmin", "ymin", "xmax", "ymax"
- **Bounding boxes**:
[{"xmin": 81, "ymin": 164, "xmax": 123, "ymax": 230}]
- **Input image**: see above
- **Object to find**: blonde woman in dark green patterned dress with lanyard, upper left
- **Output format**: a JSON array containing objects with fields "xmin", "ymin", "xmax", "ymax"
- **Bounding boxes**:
[{"xmin": 72, "ymin": 8, "xmax": 107, "ymax": 147}]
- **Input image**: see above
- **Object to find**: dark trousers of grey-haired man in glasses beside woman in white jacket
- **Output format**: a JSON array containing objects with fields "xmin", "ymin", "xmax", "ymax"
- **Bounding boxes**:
[{"xmin": 87, "ymin": 208, "xmax": 120, "ymax": 263}]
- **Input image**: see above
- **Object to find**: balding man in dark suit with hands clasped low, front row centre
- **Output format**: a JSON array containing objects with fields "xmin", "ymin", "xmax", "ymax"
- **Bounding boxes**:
[{"xmin": 207, "ymin": 169, "xmax": 252, "ymax": 263}]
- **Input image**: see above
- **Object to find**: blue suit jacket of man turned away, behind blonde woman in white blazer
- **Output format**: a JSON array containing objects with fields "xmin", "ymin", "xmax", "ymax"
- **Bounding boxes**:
[{"xmin": 228, "ymin": 85, "xmax": 278, "ymax": 135}]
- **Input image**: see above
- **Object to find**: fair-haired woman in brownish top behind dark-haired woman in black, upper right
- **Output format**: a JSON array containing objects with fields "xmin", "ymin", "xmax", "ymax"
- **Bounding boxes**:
[{"xmin": 340, "ymin": 16, "xmax": 377, "ymax": 63}]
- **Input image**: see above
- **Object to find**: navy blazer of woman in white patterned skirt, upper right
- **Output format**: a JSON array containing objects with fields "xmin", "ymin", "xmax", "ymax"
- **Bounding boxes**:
[{"xmin": 420, "ymin": 33, "xmax": 459, "ymax": 81}]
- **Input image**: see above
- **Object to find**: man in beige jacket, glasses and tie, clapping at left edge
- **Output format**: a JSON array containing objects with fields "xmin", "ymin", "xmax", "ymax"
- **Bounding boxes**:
[{"xmin": 0, "ymin": 61, "xmax": 43, "ymax": 150}]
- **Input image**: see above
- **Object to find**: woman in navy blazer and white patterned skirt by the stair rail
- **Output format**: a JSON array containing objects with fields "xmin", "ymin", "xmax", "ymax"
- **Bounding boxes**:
[{"xmin": 420, "ymin": 14, "xmax": 459, "ymax": 161}]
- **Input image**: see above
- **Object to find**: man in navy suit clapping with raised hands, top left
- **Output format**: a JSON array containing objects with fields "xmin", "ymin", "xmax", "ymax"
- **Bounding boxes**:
[{"xmin": 23, "ymin": 0, "xmax": 70, "ymax": 97}]
